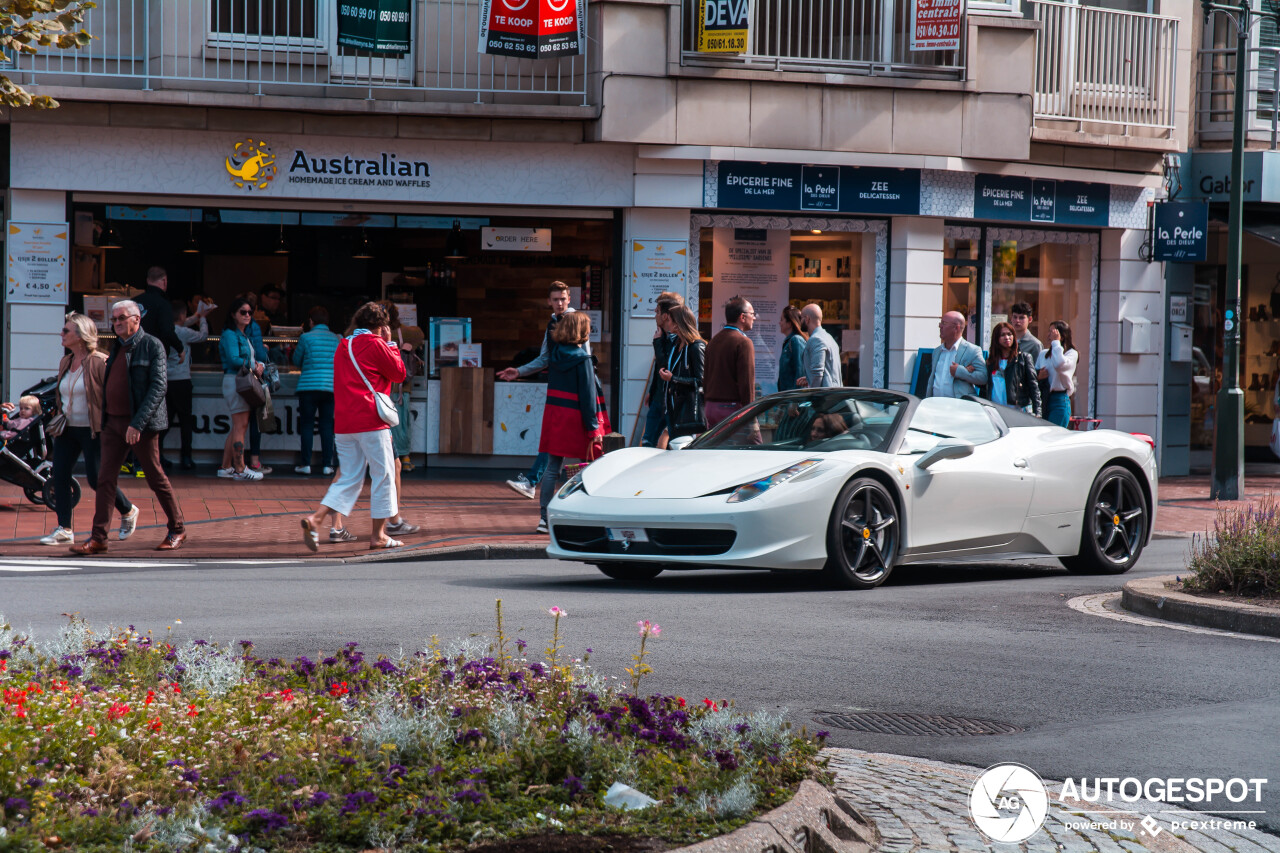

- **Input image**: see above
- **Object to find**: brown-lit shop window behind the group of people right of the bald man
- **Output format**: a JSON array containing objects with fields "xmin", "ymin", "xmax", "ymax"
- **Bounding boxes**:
[{"xmin": 984, "ymin": 229, "xmax": 1097, "ymax": 416}]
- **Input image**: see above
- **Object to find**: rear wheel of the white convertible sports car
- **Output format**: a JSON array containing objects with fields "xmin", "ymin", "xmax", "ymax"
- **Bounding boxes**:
[{"xmin": 1061, "ymin": 465, "xmax": 1151, "ymax": 575}]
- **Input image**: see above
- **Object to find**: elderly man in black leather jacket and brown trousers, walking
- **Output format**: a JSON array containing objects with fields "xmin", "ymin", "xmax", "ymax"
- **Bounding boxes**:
[{"xmin": 70, "ymin": 300, "xmax": 187, "ymax": 555}]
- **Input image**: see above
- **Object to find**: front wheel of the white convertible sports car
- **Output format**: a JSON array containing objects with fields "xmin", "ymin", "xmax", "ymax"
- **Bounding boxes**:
[{"xmin": 822, "ymin": 476, "xmax": 901, "ymax": 589}]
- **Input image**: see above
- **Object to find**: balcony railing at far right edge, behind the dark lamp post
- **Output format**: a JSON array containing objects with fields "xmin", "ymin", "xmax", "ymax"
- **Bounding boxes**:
[{"xmin": 1196, "ymin": 47, "xmax": 1280, "ymax": 149}]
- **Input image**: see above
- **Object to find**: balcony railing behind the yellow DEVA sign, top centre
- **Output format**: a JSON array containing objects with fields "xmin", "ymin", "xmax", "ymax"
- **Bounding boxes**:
[{"xmin": 681, "ymin": 0, "xmax": 966, "ymax": 79}]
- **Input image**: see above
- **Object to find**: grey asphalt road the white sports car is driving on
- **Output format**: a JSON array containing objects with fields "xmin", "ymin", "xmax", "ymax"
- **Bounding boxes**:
[{"xmin": 0, "ymin": 540, "xmax": 1280, "ymax": 831}]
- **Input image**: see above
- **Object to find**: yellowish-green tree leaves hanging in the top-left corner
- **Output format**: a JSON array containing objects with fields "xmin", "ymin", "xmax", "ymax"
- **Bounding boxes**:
[{"xmin": 0, "ymin": 0, "xmax": 96, "ymax": 109}]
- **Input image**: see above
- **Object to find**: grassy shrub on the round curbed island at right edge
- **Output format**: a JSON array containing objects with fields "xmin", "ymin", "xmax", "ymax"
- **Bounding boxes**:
[{"xmin": 1183, "ymin": 493, "xmax": 1280, "ymax": 597}]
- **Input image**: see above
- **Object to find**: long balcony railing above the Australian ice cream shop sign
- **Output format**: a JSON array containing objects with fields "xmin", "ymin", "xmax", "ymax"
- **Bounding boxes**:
[{"xmin": 10, "ymin": 0, "xmax": 588, "ymax": 106}]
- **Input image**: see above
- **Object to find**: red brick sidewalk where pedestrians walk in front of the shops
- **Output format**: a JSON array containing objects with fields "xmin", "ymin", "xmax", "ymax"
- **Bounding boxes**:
[{"xmin": 0, "ymin": 471, "xmax": 1280, "ymax": 560}]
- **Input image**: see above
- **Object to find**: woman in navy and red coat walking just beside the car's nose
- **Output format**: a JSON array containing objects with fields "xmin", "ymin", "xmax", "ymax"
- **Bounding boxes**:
[{"xmin": 538, "ymin": 311, "xmax": 609, "ymax": 533}]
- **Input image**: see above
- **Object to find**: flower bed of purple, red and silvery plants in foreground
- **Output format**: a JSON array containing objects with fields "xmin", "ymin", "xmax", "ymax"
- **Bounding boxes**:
[{"xmin": 0, "ymin": 602, "xmax": 822, "ymax": 853}]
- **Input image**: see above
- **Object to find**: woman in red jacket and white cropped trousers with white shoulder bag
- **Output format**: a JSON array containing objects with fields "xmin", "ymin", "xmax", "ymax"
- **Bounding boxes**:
[{"xmin": 302, "ymin": 302, "xmax": 404, "ymax": 551}]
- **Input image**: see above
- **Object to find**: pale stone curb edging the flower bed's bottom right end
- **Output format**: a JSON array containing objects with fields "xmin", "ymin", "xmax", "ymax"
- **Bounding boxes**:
[{"xmin": 672, "ymin": 779, "xmax": 879, "ymax": 853}]
